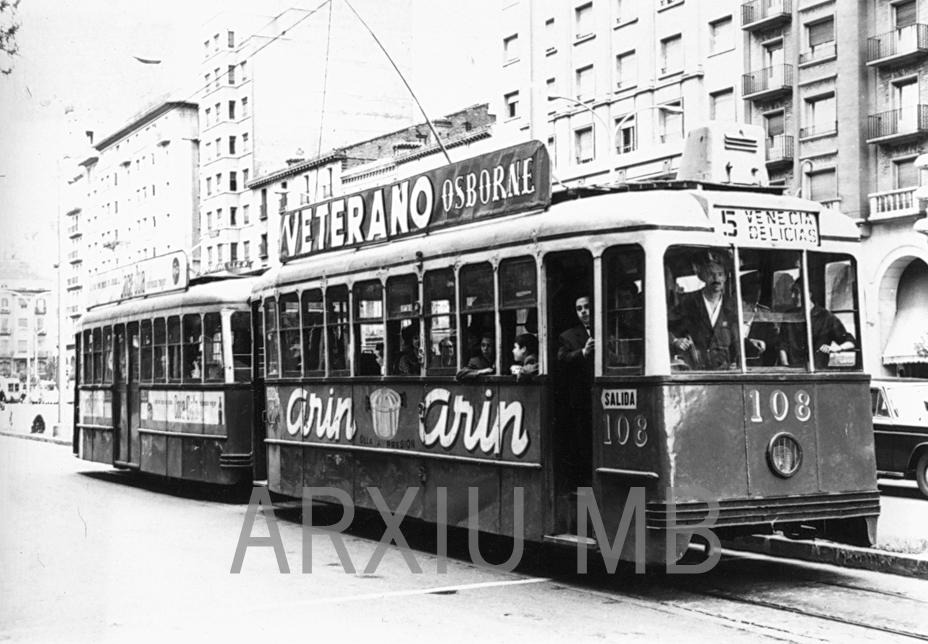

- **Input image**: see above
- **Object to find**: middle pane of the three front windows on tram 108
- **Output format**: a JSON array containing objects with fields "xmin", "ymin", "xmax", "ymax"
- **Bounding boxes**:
[{"xmin": 739, "ymin": 249, "xmax": 808, "ymax": 370}]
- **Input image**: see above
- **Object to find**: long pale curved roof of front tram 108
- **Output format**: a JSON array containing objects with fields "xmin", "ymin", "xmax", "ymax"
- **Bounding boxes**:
[{"xmin": 255, "ymin": 182, "xmax": 860, "ymax": 294}]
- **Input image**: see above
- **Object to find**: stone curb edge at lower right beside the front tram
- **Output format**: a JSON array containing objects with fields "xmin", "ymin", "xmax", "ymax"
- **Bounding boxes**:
[{"xmin": 723, "ymin": 536, "xmax": 928, "ymax": 579}]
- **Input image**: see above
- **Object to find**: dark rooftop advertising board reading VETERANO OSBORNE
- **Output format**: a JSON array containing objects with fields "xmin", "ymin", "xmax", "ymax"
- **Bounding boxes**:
[{"xmin": 280, "ymin": 141, "xmax": 551, "ymax": 261}]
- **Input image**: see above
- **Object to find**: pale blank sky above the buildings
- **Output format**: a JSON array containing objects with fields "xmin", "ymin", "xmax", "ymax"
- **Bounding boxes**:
[{"xmin": 0, "ymin": 0, "xmax": 499, "ymax": 278}]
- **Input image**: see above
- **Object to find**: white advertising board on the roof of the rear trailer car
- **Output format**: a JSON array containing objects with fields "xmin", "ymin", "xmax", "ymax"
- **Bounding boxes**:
[{"xmin": 87, "ymin": 250, "xmax": 187, "ymax": 308}]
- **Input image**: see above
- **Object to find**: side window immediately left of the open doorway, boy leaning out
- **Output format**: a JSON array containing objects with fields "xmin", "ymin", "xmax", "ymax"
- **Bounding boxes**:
[{"xmin": 499, "ymin": 257, "xmax": 538, "ymax": 374}]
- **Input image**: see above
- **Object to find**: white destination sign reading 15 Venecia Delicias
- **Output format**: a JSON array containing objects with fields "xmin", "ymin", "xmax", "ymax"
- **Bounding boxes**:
[{"xmin": 713, "ymin": 207, "xmax": 821, "ymax": 248}]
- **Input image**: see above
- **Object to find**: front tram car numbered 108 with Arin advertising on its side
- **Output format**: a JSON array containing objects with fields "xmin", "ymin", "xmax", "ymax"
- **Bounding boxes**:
[{"xmin": 253, "ymin": 124, "xmax": 879, "ymax": 563}]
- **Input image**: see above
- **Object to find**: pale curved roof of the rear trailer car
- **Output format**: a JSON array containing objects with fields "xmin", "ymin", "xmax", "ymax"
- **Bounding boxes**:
[{"xmin": 80, "ymin": 277, "xmax": 256, "ymax": 327}]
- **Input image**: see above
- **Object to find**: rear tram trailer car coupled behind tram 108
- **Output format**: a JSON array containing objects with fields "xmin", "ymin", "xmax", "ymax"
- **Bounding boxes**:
[{"xmin": 73, "ymin": 278, "xmax": 265, "ymax": 485}]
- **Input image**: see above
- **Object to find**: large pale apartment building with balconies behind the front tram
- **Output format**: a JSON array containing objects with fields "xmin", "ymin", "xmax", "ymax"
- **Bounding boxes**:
[{"xmin": 496, "ymin": 0, "xmax": 928, "ymax": 376}]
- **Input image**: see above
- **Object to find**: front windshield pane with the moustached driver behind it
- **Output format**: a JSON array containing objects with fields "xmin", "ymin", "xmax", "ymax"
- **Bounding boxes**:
[{"xmin": 664, "ymin": 246, "xmax": 741, "ymax": 372}]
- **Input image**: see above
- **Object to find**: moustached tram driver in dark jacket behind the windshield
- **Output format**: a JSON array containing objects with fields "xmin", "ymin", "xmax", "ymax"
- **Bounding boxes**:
[{"xmin": 668, "ymin": 252, "xmax": 741, "ymax": 371}]
